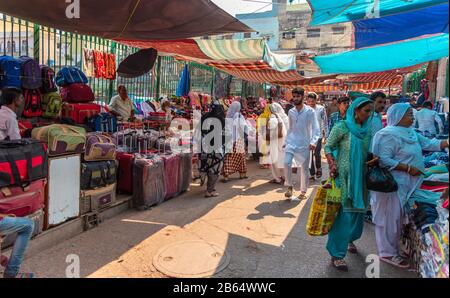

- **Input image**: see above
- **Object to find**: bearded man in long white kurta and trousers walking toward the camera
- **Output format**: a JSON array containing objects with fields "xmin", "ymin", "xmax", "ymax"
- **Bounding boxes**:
[{"xmin": 284, "ymin": 88, "xmax": 321, "ymax": 201}]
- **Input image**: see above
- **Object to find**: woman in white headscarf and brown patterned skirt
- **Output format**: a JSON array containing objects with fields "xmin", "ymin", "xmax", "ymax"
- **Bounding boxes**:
[{"xmin": 223, "ymin": 101, "xmax": 251, "ymax": 182}]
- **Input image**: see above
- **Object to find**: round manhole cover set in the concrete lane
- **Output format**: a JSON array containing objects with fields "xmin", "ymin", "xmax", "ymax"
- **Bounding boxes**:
[{"xmin": 153, "ymin": 240, "xmax": 230, "ymax": 278}]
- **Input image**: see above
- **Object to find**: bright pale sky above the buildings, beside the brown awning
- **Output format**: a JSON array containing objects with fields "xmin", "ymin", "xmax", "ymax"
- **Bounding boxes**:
[{"xmin": 212, "ymin": 0, "xmax": 306, "ymax": 16}]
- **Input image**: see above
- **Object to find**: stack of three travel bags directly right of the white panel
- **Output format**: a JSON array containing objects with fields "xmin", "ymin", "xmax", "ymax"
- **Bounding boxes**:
[{"xmin": 80, "ymin": 132, "xmax": 118, "ymax": 215}]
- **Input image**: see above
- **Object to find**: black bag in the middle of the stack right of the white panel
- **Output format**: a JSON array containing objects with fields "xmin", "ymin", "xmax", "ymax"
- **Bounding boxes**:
[{"xmin": 80, "ymin": 160, "xmax": 119, "ymax": 190}]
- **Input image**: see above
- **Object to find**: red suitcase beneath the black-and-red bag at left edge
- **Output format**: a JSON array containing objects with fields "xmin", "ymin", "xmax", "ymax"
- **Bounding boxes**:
[{"xmin": 0, "ymin": 179, "xmax": 47, "ymax": 217}]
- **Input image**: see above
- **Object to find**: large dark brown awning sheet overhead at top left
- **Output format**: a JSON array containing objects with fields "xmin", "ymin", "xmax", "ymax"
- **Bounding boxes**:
[{"xmin": 0, "ymin": 0, "xmax": 253, "ymax": 40}]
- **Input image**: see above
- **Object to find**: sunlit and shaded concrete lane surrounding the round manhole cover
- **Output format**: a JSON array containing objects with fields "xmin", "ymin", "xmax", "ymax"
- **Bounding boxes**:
[{"xmin": 22, "ymin": 162, "xmax": 416, "ymax": 278}]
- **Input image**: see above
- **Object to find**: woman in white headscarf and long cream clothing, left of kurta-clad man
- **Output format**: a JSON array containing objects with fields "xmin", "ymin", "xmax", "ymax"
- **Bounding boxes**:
[{"xmin": 267, "ymin": 103, "xmax": 289, "ymax": 185}]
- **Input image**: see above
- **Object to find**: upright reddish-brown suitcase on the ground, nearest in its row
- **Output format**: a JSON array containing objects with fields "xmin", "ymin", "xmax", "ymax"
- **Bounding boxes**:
[{"xmin": 133, "ymin": 156, "xmax": 166, "ymax": 210}]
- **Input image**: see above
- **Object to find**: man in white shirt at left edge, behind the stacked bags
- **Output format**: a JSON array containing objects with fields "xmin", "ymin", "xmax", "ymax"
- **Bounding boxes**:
[{"xmin": 0, "ymin": 88, "xmax": 24, "ymax": 141}]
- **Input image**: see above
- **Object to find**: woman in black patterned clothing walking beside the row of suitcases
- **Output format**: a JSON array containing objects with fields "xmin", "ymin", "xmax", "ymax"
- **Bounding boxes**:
[{"xmin": 197, "ymin": 101, "xmax": 225, "ymax": 198}]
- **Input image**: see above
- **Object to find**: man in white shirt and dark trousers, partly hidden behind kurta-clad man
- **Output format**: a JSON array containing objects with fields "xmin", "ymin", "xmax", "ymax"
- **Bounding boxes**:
[{"xmin": 306, "ymin": 92, "xmax": 328, "ymax": 180}]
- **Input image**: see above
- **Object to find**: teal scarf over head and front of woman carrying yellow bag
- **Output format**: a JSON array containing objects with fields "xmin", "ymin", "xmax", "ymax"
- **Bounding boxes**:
[{"xmin": 342, "ymin": 97, "xmax": 372, "ymax": 210}]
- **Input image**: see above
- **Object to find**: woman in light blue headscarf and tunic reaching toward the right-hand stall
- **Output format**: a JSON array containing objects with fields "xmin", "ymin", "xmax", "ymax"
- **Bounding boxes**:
[{"xmin": 371, "ymin": 103, "xmax": 448, "ymax": 268}]
